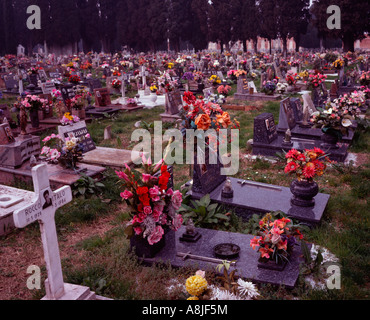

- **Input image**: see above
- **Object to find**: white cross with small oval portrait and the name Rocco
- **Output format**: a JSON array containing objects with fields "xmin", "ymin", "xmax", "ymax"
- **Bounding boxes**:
[{"xmin": 13, "ymin": 164, "xmax": 72, "ymax": 300}]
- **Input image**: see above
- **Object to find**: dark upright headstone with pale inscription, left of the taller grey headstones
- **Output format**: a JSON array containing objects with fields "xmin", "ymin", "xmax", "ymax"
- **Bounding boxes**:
[{"xmin": 253, "ymin": 113, "xmax": 278, "ymax": 144}]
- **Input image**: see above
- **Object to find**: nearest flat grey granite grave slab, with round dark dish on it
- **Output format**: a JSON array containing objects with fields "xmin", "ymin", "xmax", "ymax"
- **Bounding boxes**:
[{"xmin": 140, "ymin": 226, "xmax": 310, "ymax": 289}]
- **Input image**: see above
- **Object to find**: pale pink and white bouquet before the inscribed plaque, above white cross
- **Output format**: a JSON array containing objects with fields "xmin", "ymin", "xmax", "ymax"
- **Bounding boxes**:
[{"xmin": 41, "ymin": 134, "xmax": 90, "ymax": 170}]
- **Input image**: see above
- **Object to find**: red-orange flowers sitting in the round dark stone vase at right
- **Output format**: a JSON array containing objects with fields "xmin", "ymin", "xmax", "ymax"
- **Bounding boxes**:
[{"xmin": 284, "ymin": 147, "xmax": 330, "ymax": 181}]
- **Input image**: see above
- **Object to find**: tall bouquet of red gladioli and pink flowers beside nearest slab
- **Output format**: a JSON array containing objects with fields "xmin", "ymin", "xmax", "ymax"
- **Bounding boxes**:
[{"xmin": 116, "ymin": 156, "xmax": 183, "ymax": 245}]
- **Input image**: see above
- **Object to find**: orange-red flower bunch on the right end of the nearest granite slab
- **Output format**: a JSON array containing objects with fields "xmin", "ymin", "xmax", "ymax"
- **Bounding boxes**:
[{"xmin": 250, "ymin": 213, "xmax": 303, "ymax": 263}]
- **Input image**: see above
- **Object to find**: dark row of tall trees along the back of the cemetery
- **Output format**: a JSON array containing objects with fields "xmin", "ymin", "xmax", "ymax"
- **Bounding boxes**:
[{"xmin": 0, "ymin": 0, "xmax": 370, "ymax": 55}]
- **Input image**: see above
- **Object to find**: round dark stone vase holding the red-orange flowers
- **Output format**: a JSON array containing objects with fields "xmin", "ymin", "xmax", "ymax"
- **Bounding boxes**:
[{"xmin": 290, "ymin": 179, "xmax": 319, "ymax": 207}]
